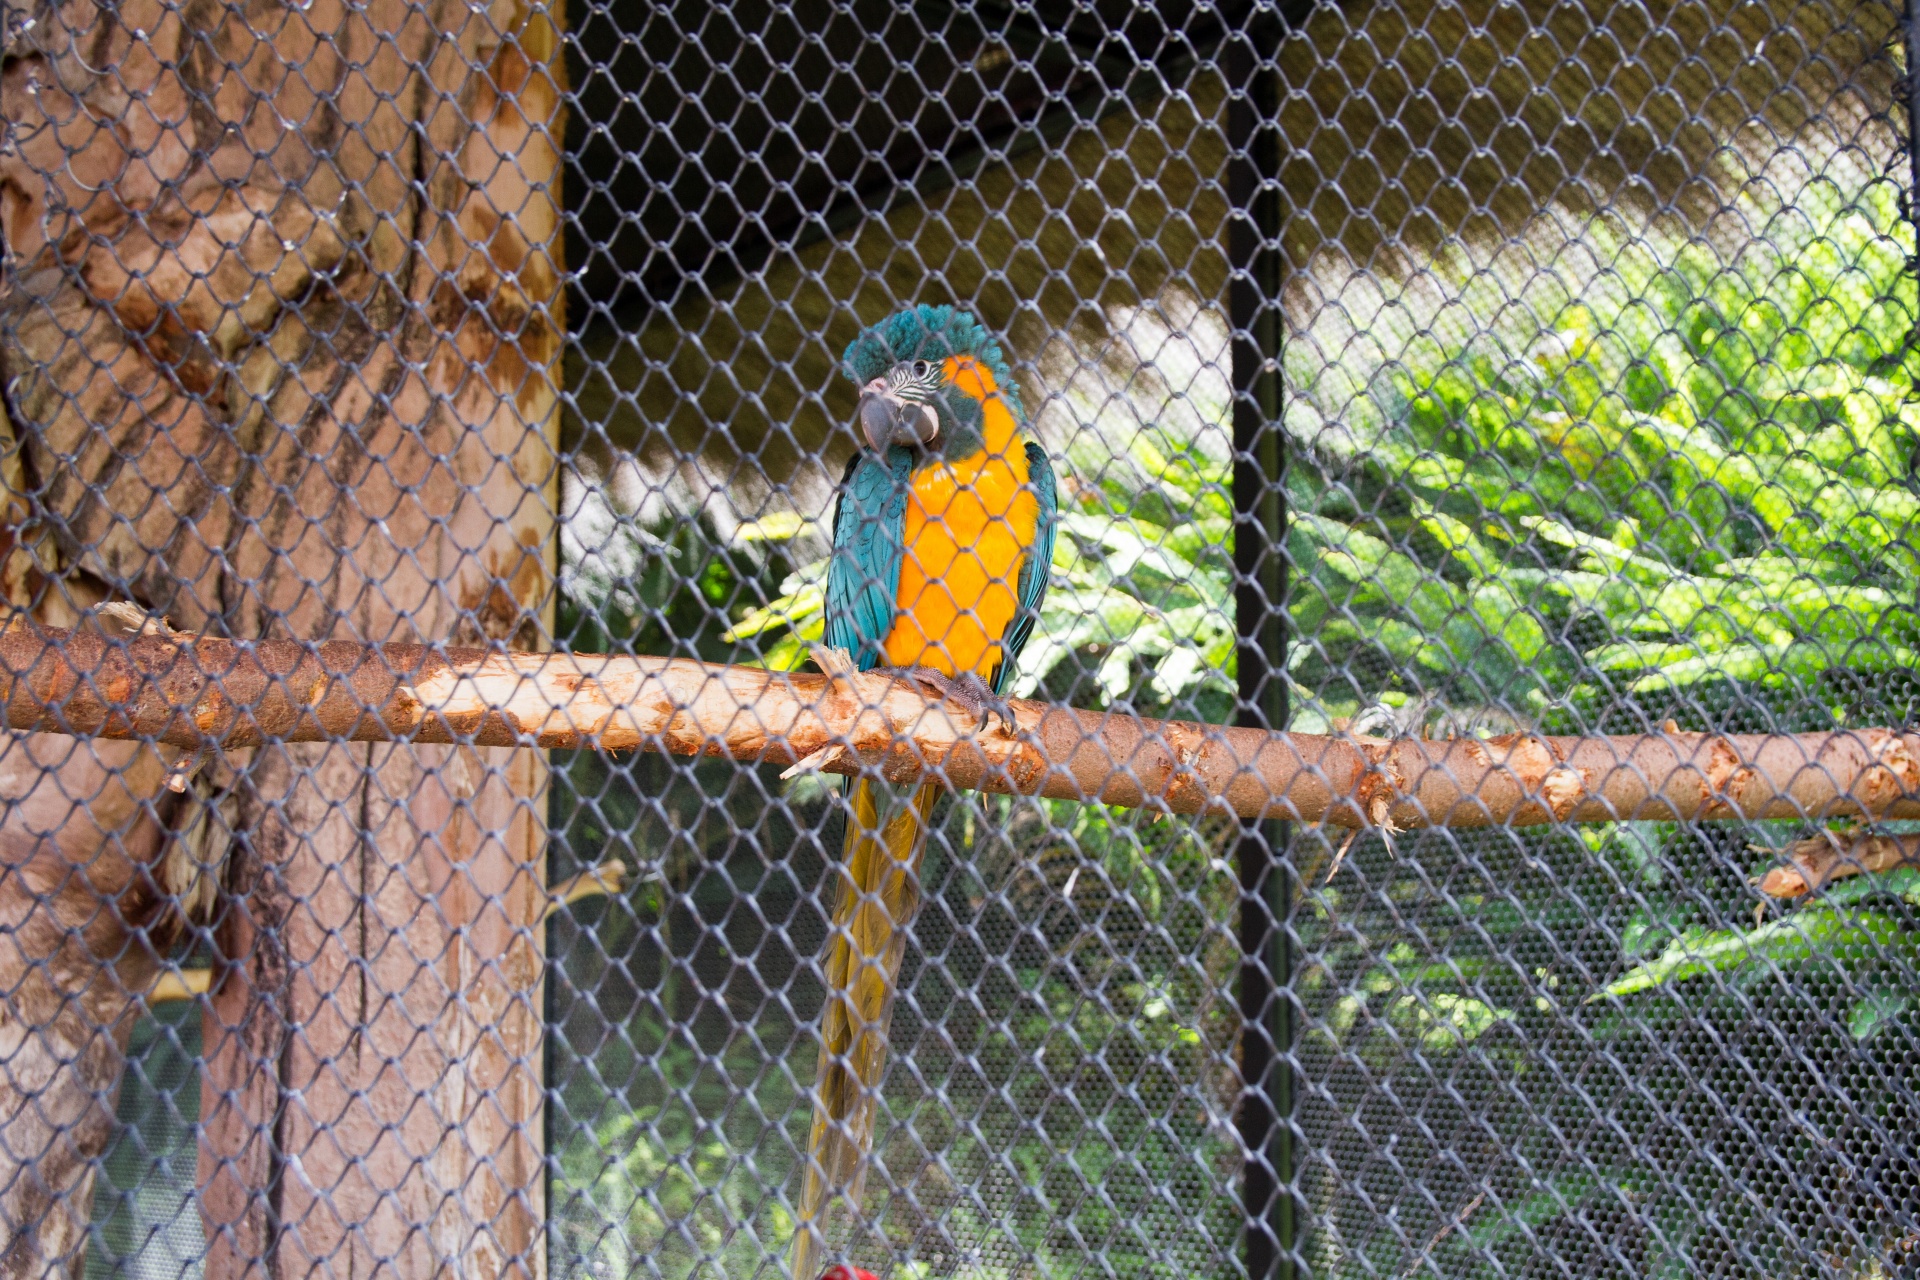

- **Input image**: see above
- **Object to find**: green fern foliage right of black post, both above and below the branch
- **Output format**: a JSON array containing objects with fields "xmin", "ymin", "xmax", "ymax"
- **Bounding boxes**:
[{"xmin": 1288, "ymin": 175, "xmax": 1920, "ymax": 1276}]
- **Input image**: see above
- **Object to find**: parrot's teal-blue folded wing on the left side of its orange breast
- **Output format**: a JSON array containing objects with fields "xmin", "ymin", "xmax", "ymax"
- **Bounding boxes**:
[{"xmin": 826, "ymin": 449, "xmax": 914, "ymax": 672}]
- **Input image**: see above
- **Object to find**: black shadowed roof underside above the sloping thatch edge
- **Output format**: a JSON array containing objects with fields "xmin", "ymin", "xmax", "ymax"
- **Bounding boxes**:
[{"xmin": 566, "ymin": 0, "xmax": 1274, "ymax": 313}]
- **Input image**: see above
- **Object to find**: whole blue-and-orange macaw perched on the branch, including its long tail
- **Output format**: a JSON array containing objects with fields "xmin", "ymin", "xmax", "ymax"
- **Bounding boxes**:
[{"xmin": 793, "ymin": 307, "xmax": 1058, "ymax": 1280}]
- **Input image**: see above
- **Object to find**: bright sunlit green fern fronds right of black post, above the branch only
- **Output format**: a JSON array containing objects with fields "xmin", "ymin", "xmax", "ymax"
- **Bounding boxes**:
[{"xmin": 1292, "ymin": 177, "xmax": 1920, "ymax": 722}]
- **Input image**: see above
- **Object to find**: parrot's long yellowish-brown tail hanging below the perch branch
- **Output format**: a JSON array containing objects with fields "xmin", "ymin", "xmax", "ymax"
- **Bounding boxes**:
[{"xmin": 791, "ymin": 777, "xmax": 941, "ymax": 1280}]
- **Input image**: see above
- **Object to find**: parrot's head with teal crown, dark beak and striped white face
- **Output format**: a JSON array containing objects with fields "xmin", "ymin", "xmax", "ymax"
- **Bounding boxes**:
[{"xmin": 840, "ymin": 305, "xmax": 1021, "ymax": 458}]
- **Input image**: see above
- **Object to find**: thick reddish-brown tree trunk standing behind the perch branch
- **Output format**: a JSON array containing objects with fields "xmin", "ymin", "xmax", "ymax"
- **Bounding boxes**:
[{"xmin": 0, "ymin": 0, "xmax": 563, "ymax": 1278}]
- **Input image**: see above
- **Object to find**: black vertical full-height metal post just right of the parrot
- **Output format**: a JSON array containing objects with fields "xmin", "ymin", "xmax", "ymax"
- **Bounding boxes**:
[{"xmin": 1223, "ymin": 6, "xmax": 1298, "ymax": 1280}]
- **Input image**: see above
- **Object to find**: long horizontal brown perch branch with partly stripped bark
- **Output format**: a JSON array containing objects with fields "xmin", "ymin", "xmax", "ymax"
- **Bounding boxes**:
[{"xmin": 0, "ymin": 626, "xmax": 1920, "ymax": 829}]
